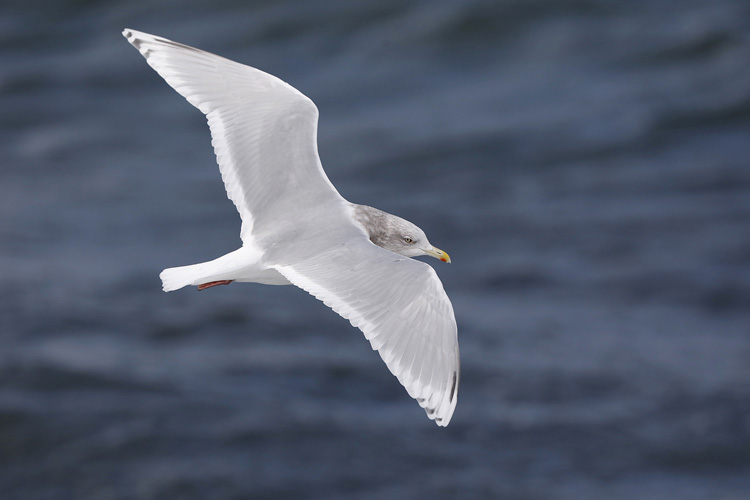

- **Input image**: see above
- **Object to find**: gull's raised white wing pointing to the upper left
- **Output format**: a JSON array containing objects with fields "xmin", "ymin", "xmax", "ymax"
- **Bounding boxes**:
[{"xmin": 123, "ymin": 29, "xmax": 346, "ymax": 244}]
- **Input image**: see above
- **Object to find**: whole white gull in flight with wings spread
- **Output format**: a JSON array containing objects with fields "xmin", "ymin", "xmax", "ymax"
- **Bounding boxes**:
[{"xmin": 123, "ymin": 29, "xmax": 459, "ymax": 426}]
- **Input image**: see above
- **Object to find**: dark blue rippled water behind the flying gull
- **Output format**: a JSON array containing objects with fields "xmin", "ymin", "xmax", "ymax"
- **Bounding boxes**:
[{"xmin": 0, "ymin": 0, "xmax": 750, "ymax": 500}]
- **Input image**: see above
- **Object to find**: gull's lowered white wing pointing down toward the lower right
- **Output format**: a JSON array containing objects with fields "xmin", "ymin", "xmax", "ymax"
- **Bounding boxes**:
[{"xmin": 270, "ymin": 238, "xmax": 459, "ymax": 426}]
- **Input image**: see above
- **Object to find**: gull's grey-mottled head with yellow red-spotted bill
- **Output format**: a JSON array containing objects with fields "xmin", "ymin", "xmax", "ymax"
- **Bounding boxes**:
[{"xmin": 354, "ymin": 205, "xmax": 451, "ymax": 262}]
